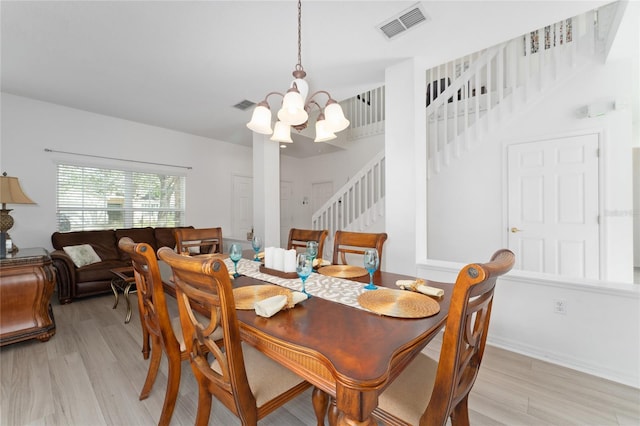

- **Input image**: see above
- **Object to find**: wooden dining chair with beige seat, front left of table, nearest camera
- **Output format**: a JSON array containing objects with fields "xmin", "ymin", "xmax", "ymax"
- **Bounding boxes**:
[{"xmin": 158, "ymin": 247, "xmax": 311, "ymax": 426}]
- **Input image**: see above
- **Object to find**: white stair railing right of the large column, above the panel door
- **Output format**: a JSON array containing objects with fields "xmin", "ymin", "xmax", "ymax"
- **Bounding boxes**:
[{"xmin": 426, "ymin": 11, "xmax": 597, "ymax": 177}]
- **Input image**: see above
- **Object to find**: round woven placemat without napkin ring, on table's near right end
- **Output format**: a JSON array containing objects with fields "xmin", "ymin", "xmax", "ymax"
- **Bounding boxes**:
[{"xmin": 358, "ymin": 288, "xmax": 440, "ymax": 318}]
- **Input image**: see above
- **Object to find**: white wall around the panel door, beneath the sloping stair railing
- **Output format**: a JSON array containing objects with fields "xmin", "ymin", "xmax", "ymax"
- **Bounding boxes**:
[{"xmin": 428, "ymin": 56, "xmax": 633, "ymax": 282}]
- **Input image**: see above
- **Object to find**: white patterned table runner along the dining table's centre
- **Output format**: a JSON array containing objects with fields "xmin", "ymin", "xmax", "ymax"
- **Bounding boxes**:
[{"xmin": 224, "ymin": 258, "xmax": 372, "ymax": 310}]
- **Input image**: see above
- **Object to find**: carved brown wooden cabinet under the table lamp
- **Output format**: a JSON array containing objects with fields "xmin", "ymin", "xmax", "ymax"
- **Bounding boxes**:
[{"xmin": 0, "ymin": 248, "xmax": 56, "ymax": 346}]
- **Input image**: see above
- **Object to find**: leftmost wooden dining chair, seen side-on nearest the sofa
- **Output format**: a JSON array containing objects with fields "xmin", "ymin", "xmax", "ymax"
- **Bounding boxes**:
[{"xmin": 118, "ymin": 237, "xmax": 222, "ymax": 425}]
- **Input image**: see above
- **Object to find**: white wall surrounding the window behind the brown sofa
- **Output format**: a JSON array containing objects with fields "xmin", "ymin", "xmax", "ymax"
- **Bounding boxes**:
[{"xmin": 0, "ymin": 93, "xmax": 252, "ymax": 249}]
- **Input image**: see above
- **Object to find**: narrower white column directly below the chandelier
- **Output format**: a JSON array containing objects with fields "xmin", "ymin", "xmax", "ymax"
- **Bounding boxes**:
[{"xmin": 253, "ymin": 133, "xmax": 280, "ymax": 247}]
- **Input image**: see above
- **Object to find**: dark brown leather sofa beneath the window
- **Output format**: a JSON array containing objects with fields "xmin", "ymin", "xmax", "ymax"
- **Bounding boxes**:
[{"xmin": 51, "ymin": 226, "xmax": 193, "ymax": 304}]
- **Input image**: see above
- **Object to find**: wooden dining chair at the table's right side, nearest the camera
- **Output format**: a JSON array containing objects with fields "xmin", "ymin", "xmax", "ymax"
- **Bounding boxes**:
[{"xmin": 373, "ymin": 249, "xmax": 515, "ymax": 426}]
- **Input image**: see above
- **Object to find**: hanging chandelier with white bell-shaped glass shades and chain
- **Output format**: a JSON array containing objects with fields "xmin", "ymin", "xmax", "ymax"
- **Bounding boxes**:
[{"xmin": 247, "ymin": 0, "xmax": 349, "ymax": 143}]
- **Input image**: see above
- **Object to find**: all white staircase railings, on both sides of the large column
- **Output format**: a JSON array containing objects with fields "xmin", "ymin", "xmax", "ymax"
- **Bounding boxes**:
[{"xmin": 312, "ymin": 2, "xmax": 619, "ymax": 248}]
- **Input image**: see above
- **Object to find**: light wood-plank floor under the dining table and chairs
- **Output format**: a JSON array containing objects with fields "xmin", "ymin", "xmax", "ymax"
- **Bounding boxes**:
[{"xmin": 0, "ymin": 295, "xmax": 640, "ymax": 426}]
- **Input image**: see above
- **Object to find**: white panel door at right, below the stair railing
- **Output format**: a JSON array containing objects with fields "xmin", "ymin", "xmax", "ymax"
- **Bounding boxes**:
[{"xmin": 508, "ymin": 134, "xmax": 600, "ymax": 279}]
